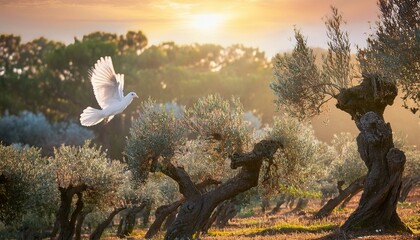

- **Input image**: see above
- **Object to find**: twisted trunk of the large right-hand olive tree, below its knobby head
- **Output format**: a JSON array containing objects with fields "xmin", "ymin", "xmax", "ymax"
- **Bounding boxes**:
[{"xmin": 341, "ymin": 112, "xmax": 411, "ymax": 233}]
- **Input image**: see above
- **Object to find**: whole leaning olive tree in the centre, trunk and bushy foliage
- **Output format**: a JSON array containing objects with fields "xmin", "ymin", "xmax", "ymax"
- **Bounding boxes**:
[{"xmin": 125, "ymin": 95, "xmax": 336, "ymax": 239}]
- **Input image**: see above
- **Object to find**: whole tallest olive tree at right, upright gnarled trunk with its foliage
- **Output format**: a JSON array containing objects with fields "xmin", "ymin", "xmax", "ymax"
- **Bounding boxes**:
[{"xmin": 271, "ymin": 0, "xmax": 419, "ymax": 233}]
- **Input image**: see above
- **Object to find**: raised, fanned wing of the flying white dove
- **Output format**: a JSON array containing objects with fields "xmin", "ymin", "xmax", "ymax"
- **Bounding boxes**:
[{"xmin": 90, "ymin": 57, "xmax": 124, "ymax": 109}]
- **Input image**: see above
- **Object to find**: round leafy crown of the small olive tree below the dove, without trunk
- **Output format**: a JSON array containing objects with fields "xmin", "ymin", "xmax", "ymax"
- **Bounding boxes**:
[{"xmin": 50, "ymin": 141, "xmax": 128, "ymax": 204}]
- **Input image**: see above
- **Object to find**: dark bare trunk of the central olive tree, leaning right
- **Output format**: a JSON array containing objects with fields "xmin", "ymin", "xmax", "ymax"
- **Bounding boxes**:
[{"xmin": 165, "ymin": 140, "xmax": 282, "ymax": 239}]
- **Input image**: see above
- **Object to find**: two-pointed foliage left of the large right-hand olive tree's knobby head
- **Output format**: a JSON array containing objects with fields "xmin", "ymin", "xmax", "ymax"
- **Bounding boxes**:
[{"xmin": 270, "ymin": 8, "xmax": 354, "ymax": 119}]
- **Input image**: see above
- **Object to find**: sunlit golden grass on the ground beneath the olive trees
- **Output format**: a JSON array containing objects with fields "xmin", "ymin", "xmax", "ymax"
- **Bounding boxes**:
[{"xmin": 107, "ymin": 187, "xmax": 420, "ymax": 240}]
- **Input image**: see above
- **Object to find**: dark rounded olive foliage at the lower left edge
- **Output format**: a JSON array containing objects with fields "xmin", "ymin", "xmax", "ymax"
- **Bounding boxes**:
[{"xmin": 0, "ymin": 145, "xmax": 58, "ymax": 227}]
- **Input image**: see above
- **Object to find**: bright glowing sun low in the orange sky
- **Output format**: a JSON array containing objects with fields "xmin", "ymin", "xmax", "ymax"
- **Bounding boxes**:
[{"xmin": 191, "ymin": 13, "xmax": 225, "ymax": 31}]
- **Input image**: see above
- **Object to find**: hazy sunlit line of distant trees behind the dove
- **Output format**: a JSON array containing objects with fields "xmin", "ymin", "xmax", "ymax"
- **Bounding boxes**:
[{"xmin": 0, "ymin": 31, "xmax": 274, "ymax": 158}]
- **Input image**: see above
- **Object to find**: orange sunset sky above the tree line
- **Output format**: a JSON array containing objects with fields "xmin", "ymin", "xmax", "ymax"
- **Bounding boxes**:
[{"xmin": 0, "ymin": 0, "xmax": 378, "ymax": 57}]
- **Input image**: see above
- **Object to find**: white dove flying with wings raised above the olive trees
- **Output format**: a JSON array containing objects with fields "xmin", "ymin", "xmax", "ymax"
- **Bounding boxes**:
[{"xmin": 80, "ymin": 57, "xmax": 138, "ymax": 126}]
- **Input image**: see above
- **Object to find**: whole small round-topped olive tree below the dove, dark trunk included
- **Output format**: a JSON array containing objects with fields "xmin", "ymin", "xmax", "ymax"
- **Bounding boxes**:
[{"xmin": 50, "ymin": 141, "xmax": 126, "ymax": 239}]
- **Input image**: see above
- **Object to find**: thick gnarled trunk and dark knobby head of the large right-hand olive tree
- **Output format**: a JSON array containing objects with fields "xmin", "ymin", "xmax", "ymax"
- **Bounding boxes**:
[{"xmin": 337, "ymin": 75, "xmax": 411, "ymax": 233}]
